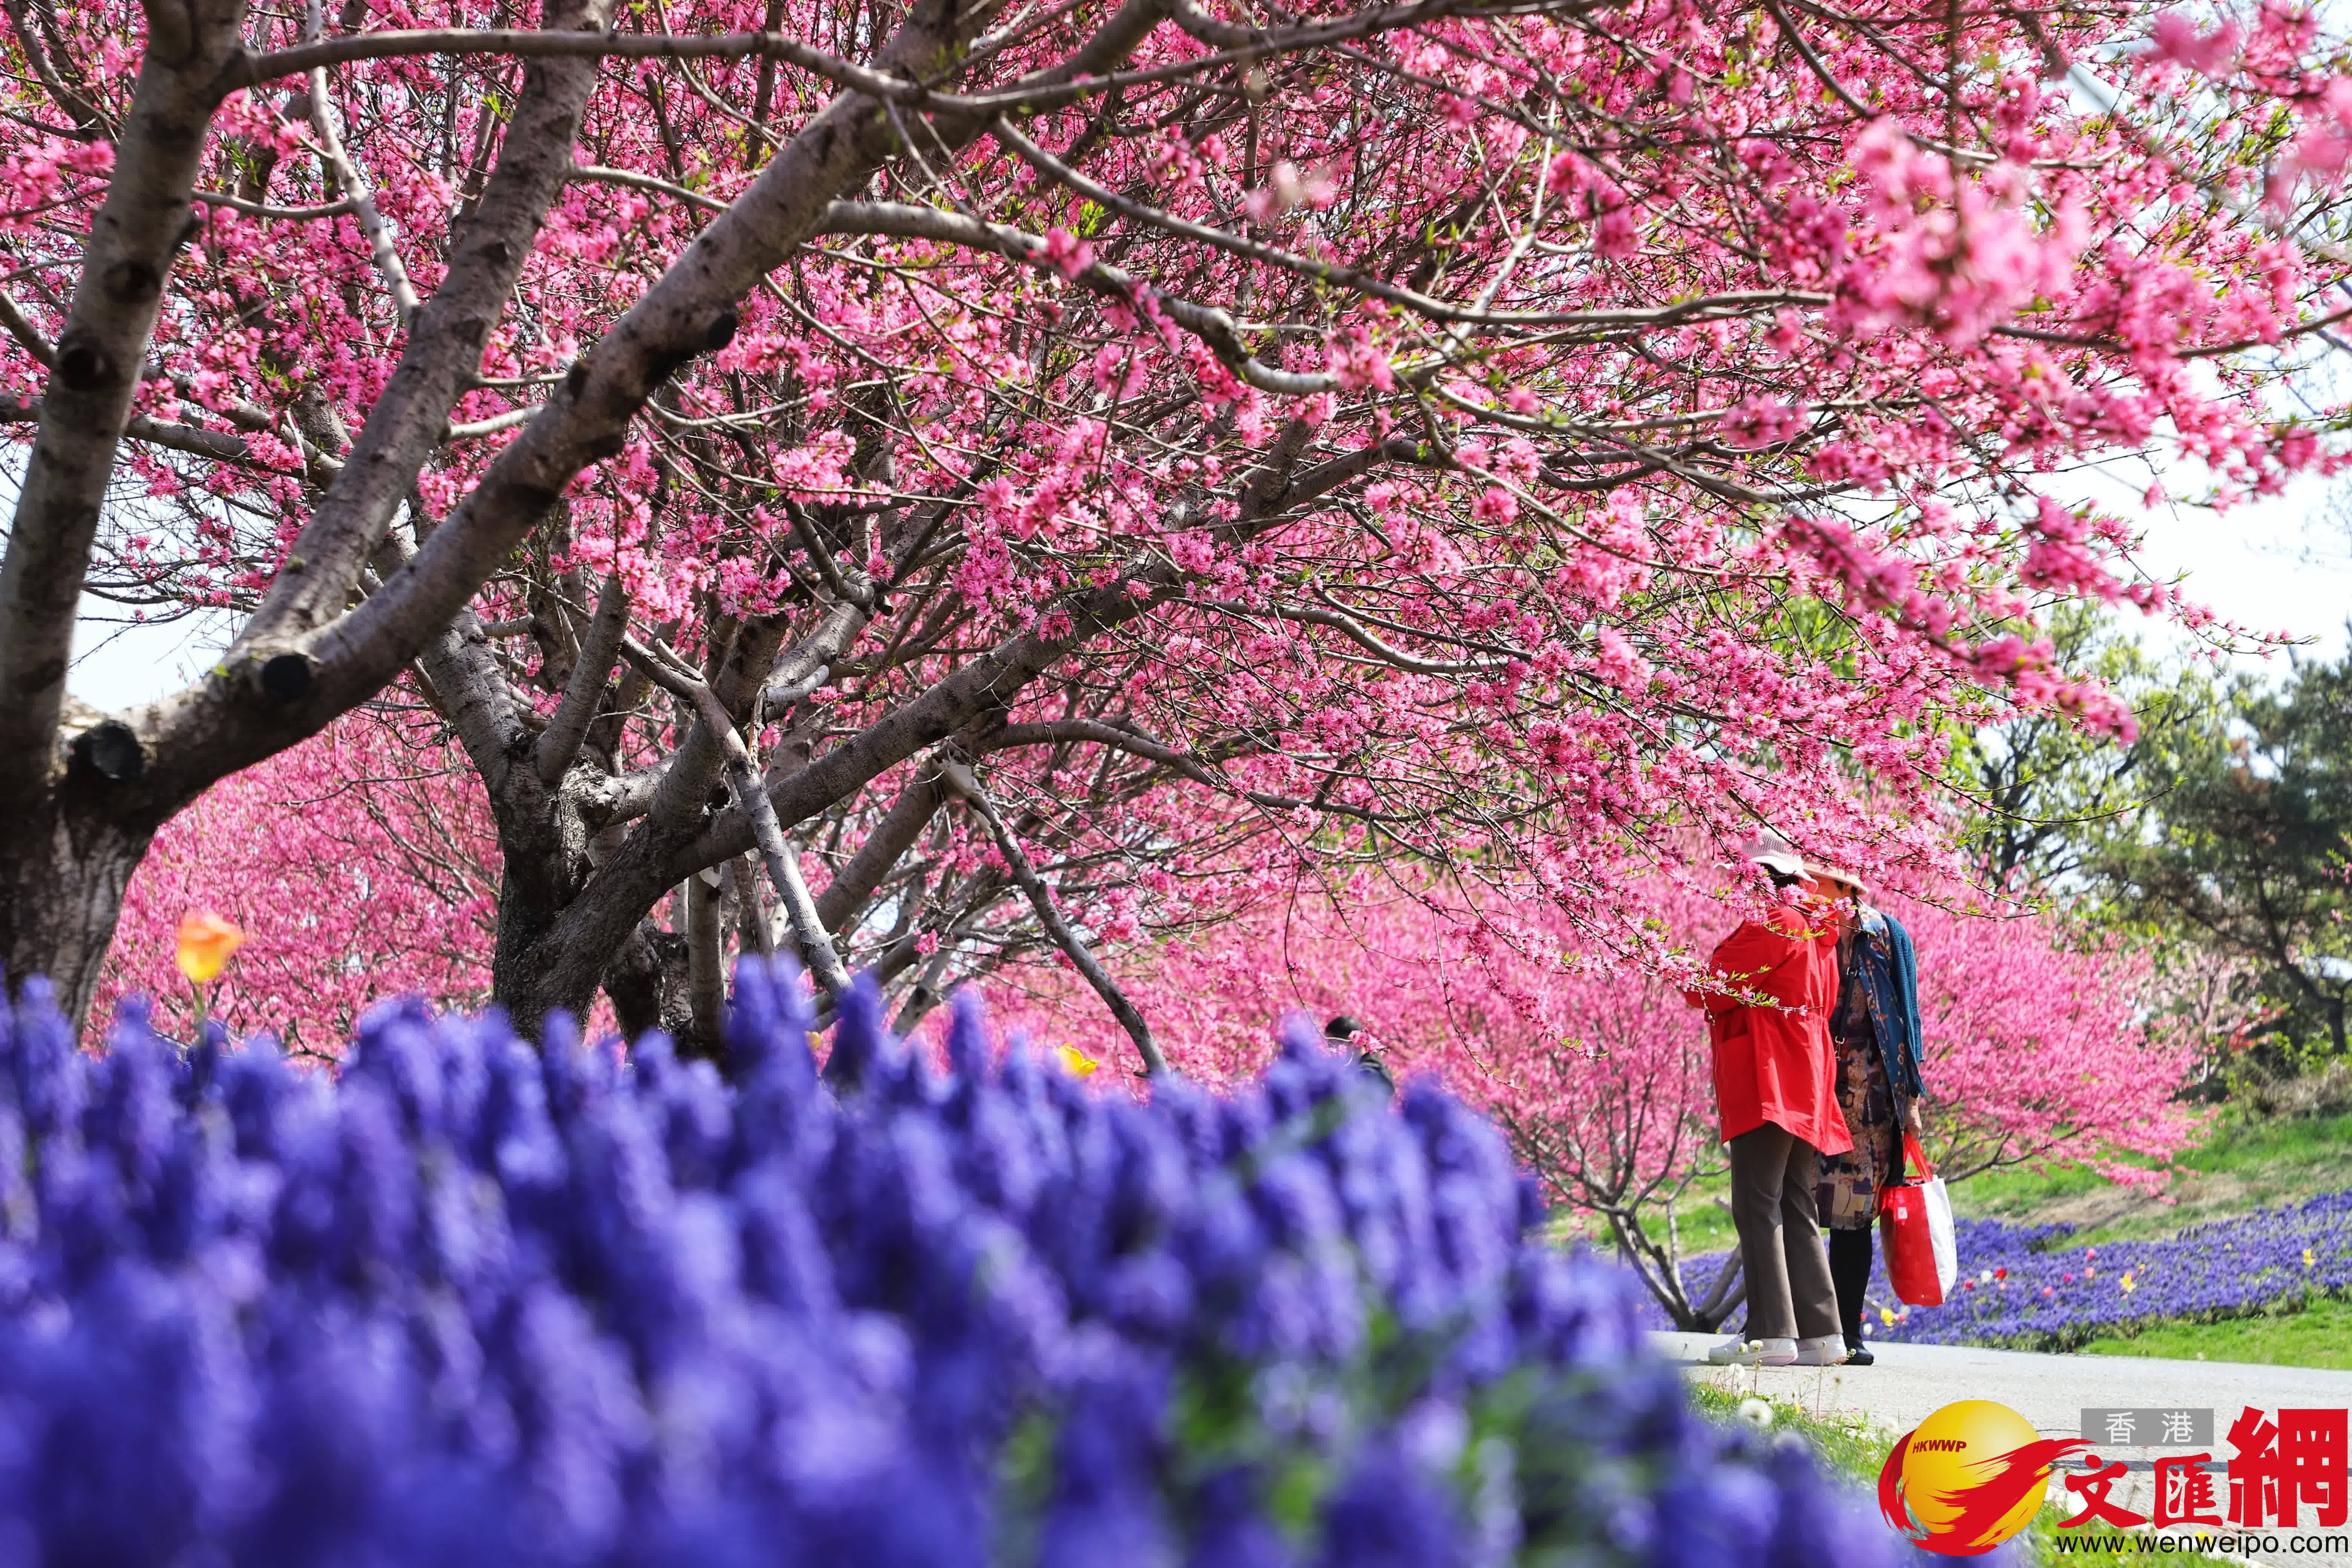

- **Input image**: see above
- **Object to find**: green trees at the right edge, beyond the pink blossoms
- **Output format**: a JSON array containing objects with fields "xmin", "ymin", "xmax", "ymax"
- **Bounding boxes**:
[{"xmin": 1948, "ymin": 606, "xmax": 2352, "ymax": 1091}]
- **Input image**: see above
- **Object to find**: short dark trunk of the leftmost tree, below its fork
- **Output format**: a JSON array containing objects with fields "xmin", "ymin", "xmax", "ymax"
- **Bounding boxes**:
[{"xmin": 0, "ymin": 799, "xmax": 155, "ymax": 1025}]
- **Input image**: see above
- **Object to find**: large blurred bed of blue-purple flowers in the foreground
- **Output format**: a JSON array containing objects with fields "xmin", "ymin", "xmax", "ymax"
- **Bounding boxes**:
[{"xmin": 0, "ymin": 964, "xmax": 1893, "ymax": 1568}]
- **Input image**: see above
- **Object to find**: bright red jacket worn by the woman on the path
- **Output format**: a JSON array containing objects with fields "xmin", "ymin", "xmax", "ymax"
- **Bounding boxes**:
[{"xmin": 1684, "ymin": 905, "xmax": 1853, "ymax": 1154}]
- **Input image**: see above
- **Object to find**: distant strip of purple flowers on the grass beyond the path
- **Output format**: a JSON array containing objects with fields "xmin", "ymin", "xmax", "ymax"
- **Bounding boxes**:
[{"xmin": 1646, "ymin": 1192, "xmax": 2352, "ymax": 1349}]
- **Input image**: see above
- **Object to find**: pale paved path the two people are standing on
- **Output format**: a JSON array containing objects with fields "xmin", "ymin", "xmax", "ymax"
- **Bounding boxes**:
[{"xmin": 1651, "ymin": 1333, "xmax": 2352, "ymax": 1563}]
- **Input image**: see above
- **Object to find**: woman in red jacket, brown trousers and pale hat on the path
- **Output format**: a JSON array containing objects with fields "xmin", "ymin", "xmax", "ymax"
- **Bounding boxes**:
[{"xmin": 1686, "ymin": 835, "xmax": 1853, "ymax": 1366}]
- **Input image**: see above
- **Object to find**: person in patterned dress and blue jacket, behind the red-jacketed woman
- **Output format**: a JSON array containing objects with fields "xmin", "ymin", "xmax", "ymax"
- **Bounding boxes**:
[{"xmin": 1809, "ymin": 865, "xmax": 1926, "ymax": 1366}]
